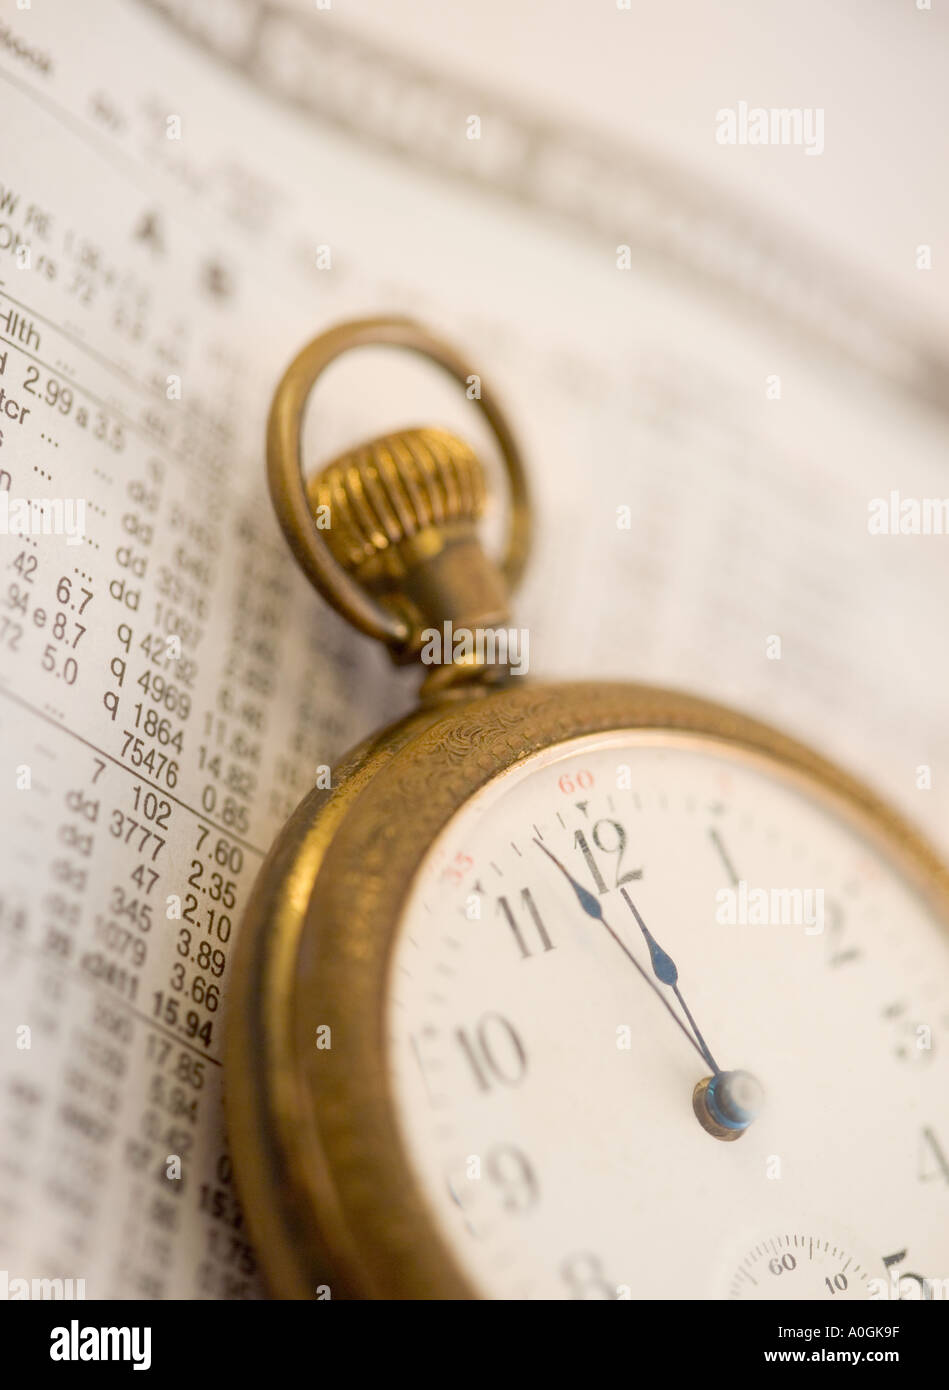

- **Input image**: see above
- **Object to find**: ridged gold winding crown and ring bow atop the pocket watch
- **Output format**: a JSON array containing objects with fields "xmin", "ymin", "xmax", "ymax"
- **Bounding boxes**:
[{"xmin": 267, "ymin": 317, "xmax": 531, "ymax": 664}]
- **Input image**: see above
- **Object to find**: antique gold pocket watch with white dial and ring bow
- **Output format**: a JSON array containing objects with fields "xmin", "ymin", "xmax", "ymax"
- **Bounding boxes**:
[{"xmin": 225, "ymin": 318, "xmax": 949, "ymax": 1302}]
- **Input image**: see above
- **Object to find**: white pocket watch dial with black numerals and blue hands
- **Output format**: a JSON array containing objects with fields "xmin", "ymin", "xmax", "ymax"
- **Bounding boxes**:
[{"xmin": 386, "ymin": 731, "xmax": 949, "ymax": 1301}]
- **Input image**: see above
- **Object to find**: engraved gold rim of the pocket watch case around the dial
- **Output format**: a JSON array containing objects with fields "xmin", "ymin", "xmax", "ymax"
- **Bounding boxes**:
[{"xmin": 225, "ymin": 682, "xmax": 949, "ymax": 1298}]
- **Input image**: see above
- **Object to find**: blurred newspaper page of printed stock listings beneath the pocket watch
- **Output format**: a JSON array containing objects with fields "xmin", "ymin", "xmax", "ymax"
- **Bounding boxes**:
[{"xmin": 0, "ymin": 0, "xmax": 949, "ymax": 1297}]
